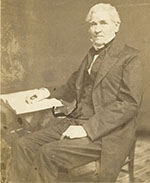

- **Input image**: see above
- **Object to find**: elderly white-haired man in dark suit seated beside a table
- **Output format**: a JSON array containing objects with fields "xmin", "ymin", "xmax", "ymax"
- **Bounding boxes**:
[{"xmin": 10, "ymin": 3, "xmax": 142, "ymax": 182}]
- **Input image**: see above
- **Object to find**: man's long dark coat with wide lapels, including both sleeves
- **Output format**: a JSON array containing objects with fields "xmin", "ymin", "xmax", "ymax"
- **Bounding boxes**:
[{"xmin": 51, "ymin": 40, "xmax": 143, "ymax": 182}]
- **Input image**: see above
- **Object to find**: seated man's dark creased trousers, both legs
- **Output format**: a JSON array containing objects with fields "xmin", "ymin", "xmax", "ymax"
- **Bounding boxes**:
[{"xmin": 9, "ymin": 119, "xmax": 101, "ymax": 182}]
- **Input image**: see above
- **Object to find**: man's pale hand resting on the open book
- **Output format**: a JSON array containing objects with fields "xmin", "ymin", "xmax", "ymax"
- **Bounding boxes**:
[{"xmin": 25, "ymin": 88, "xmax": 50, "ymax": 104}]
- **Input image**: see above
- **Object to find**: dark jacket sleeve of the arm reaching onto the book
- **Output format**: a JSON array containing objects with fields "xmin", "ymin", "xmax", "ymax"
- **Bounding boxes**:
[{"xmin": 48, "ymin": 71, "xmax": 78, "ymax": 102}]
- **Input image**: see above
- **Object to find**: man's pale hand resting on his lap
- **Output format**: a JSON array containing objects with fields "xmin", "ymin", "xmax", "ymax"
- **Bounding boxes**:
[{"xmin": 62, "ymin": 125, "xmax": 87, "ymax": 139}]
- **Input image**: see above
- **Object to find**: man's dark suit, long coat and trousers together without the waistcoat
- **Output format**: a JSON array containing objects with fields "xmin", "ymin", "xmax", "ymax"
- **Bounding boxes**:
[{"xmin": 9, "ymin": 40, "xmax": 142, "ymax": 182}]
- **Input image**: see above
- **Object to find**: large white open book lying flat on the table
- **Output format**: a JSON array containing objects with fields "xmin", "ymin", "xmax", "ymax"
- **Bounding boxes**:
[{"xmin": 0, "ymin": 90, "xmax": 63, "ymax": 114}]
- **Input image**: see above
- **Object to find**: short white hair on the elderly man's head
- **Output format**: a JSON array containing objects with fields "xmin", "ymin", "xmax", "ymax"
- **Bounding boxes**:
[{"xmin": 85, "ymin": 3, "xmax": 121, "ymax": 26}]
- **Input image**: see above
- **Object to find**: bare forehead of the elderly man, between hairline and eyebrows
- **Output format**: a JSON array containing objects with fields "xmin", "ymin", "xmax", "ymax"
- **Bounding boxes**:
[{"xmin": 91, "ymin": 11, "xmax": 112, "ymax": 22}]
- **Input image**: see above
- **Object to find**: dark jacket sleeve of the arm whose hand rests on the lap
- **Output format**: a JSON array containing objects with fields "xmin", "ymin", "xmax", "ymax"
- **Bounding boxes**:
[{"xmin": 82, "ymin": 56, "xmax": 143, "ymax": 140}]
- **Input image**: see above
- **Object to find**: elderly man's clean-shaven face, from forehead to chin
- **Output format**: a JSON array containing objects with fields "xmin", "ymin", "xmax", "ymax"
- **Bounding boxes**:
[{"xmin": 89, "ymin": 11, "xmax": 117, "ymax": 46}]
